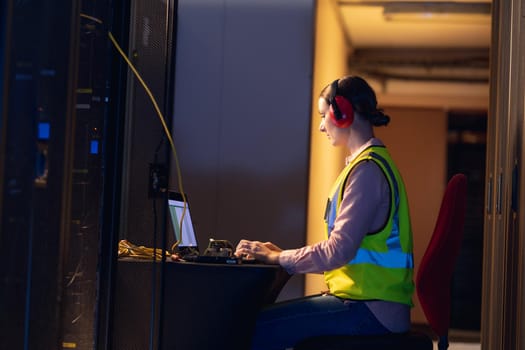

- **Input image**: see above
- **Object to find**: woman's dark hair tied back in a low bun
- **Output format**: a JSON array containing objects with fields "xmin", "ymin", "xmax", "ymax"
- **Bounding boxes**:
[{"xmin": 320, "ymin": 75, "xmax": 390, "ymax": 126}]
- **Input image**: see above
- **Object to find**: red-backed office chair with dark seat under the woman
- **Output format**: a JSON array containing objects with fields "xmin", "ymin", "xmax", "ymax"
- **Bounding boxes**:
[{"xmin": 294, "ymin": 174, "xmax": 467, "ymax": 350}]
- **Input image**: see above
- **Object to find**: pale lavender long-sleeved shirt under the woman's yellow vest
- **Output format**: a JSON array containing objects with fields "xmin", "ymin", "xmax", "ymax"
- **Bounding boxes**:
[{"xmin": 279, "ymin": 138, "xmax": 410, "ymax": 332}]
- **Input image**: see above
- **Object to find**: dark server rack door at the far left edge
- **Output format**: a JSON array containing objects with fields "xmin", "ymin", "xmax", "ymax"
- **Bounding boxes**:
[{"xmin": 0, "ymin": 0, "xmax": 78, "ymax": 349}]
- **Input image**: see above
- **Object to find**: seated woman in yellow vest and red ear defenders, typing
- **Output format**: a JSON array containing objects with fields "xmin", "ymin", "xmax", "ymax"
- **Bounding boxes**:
[{"xmin": 236, "ymin": 76, "xmax": 414, "ymax": 350}]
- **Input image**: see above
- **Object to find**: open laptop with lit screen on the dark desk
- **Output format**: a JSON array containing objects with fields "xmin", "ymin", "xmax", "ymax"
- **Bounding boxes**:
[{"xmin": 168, "ymin": 191, "xmax": 241, "ymax": 264}]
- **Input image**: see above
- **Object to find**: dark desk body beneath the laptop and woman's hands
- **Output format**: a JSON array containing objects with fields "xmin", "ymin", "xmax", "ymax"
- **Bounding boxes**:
[{"xmin": 112, "ymin": 259, "xmax": 289, "ymax": 350}]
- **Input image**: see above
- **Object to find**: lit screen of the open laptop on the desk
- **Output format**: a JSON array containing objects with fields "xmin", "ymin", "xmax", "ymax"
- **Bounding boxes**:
[{"xmin": 168, "ymin": 192, "xmax": 198, "ymax": 248}]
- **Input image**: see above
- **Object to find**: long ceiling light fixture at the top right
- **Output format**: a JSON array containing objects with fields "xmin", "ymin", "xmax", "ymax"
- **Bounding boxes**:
[{"xmin": 383, "ymin": 2, "xmax": 491, "ymax": 24}]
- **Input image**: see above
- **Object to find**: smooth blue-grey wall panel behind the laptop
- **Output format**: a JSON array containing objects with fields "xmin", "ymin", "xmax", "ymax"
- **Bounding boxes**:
[{"xmin": 170, "ymin": 0, "xmax": 314, "ymax": 298}]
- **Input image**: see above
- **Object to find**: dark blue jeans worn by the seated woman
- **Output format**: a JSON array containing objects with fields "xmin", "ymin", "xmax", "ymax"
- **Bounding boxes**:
[{"xmin": 252, "ymin": 295, "xmax": 390, "ymax": 350}]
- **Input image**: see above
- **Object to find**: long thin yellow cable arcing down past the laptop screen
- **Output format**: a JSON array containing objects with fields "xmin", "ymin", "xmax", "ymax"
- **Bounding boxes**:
[{"xmin": 80, "ymin": 13, "xmax": 188, "ymax": 250}]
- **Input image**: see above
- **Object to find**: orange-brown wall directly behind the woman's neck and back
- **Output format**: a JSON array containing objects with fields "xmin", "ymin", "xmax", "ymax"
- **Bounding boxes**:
[{"xmin": 376, "ymin": 107, "xmax": 448, "ymax": 323}]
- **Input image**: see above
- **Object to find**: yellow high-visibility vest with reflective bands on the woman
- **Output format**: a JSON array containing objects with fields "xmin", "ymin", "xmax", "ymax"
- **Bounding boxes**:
[{"xmin": 325, "ymin": 146, "xmax": 414, "ymax": 306}]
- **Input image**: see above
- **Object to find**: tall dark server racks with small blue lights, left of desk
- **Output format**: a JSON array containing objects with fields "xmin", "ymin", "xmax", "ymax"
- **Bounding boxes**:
[{"xmin": 0, "ymin": 0, "xmax": 166, "ymax": 350}]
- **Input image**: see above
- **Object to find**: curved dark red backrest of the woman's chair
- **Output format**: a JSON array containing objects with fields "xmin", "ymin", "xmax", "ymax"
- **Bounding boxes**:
[{"xmin": 416, "ymin": 174, "xmax": 467, "ymax": 336}]
